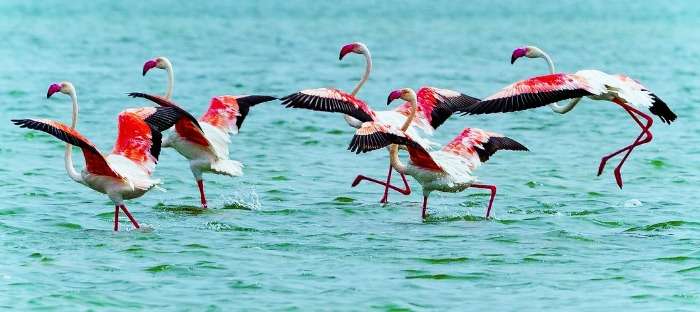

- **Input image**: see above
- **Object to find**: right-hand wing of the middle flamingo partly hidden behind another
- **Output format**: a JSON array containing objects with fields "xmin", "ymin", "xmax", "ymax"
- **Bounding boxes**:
[{"xmin": 416, "ymin": 87, "xmax": 480, "ymax": 129}]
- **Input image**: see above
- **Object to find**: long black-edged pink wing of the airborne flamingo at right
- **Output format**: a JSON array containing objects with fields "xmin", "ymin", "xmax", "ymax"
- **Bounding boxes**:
[{"xmin": 463, "ymin": 74, "xmax": 605, "ymax": 115}]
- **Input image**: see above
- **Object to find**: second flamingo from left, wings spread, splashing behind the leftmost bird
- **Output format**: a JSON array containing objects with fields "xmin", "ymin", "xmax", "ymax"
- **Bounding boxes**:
[{"xmin": 140, "ymin": 56, "xmax": 277, "ymax": 208}]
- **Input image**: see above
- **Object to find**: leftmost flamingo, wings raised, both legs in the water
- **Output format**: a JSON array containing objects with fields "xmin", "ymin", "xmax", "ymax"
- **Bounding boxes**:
[{"xmin": 12, "ymin": 82, "xmax": 184, "ymax": 231}]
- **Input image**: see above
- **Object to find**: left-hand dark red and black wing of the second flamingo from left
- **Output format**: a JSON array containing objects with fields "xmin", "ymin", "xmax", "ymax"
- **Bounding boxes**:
[{"xmin": 129, "ymin": 92, "xmax": 214, "ymax": 152}]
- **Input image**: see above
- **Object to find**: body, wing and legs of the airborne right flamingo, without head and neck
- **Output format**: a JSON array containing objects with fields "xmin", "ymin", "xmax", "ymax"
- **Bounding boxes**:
[{"xmin": 463, "ymin": 70, "xmax": 677, "ymax": 188}]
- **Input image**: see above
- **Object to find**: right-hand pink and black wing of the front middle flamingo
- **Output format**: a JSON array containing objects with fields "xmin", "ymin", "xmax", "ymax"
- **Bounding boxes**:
[{"xmin": 442, "ymin": 128, "xmax": 528, "ymax": 169}]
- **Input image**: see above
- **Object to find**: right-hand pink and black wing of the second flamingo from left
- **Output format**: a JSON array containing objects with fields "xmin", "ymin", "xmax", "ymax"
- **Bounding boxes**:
[{"xmin": 199, "ymin": 95, "xmax": 277, "ymax": 134}]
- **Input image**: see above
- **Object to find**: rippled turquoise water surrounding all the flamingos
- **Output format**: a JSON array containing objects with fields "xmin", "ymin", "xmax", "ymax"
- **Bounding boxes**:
[{"xmin": 0, "ymin": 1, "xmax": 700, "ymax": 311}]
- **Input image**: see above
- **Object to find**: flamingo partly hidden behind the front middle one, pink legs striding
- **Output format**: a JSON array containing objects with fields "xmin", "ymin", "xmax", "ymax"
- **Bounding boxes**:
[{"xmin": 280, "ymin": 42, "xmax": 479, "ymax": 204}]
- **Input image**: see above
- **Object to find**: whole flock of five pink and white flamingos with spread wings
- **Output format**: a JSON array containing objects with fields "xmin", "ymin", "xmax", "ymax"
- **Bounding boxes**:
[{"xmin": 12, "ymin": 42, "xmax": 677, "ymax": 231}]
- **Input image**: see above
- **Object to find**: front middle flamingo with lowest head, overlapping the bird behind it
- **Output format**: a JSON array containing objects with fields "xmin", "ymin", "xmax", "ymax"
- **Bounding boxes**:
[{"xmin": 348, "ymin": 88, "xmax": 528, "ymax": 219}]
